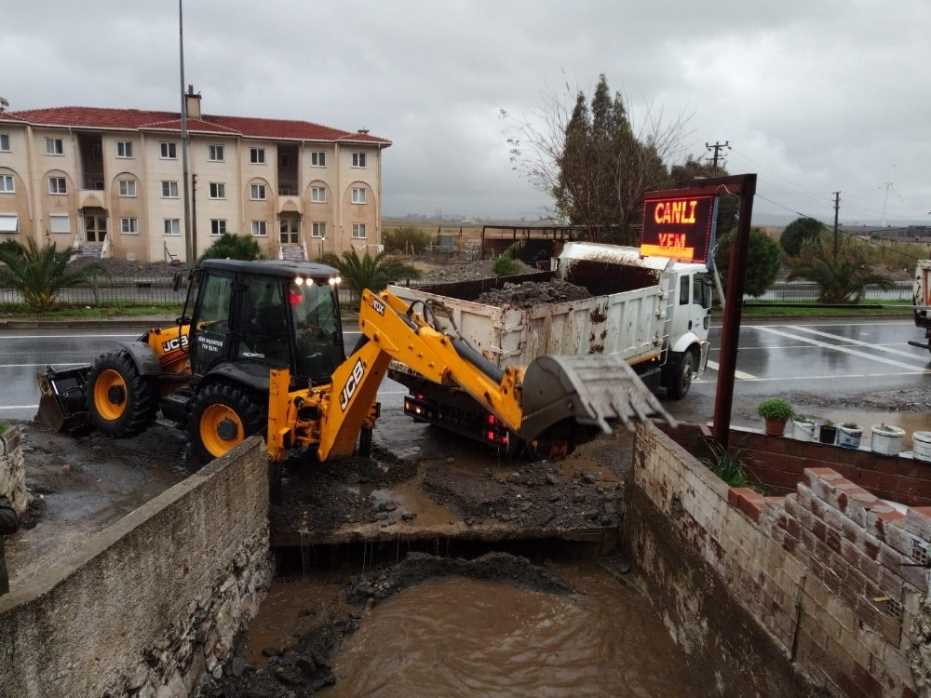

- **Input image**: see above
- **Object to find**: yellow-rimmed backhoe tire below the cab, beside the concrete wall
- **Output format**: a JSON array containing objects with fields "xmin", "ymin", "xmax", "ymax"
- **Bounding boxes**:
[{"xmin": 188, "ymin": 383, "xmax": 267, "ymax": 463}]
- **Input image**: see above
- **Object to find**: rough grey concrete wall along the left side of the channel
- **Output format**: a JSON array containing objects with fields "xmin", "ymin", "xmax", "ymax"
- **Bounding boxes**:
[{"xmin": 0, "ymin": 438, "xmax": 272, "ymax": 698}]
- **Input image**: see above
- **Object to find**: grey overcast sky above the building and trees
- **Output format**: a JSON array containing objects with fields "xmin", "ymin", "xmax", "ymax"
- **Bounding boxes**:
[{"xmin": 0, "ymin": 0, "xmax": 931, "ymax": 224}]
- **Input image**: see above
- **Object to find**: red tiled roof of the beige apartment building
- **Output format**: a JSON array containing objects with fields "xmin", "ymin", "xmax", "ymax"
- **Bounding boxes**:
[{"xmin": 0, "ymin": 107, "xmax": 391, "ymax": 145}]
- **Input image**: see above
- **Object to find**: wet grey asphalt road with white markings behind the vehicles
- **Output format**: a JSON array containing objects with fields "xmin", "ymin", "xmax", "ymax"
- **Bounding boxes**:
[{"xmin": 0, "ymin": 320, "xmax": 931, "ymax": 419}]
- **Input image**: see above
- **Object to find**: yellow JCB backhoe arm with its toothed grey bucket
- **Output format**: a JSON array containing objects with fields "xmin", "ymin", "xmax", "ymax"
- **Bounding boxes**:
[{"xmin": 268, "ymin": 291, "xmax": 673, "ymax": 461}]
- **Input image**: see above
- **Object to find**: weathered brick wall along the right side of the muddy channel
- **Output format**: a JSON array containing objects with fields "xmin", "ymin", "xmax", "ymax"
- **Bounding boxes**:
[{"xmin": 625, "ymin": 426, "xmax": 931, "ymax": 698}]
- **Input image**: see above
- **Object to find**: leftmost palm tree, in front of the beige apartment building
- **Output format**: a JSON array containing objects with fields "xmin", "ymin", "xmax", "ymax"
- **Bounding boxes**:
[{"xmin": 0, "ymin": 238, "xmax": 103, "ymax": 312}]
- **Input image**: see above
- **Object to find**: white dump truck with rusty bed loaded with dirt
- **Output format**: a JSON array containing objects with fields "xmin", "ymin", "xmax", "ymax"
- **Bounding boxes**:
[{"xmin": 389, "ymin": 242, "xmax": 712, "ymax": 447}]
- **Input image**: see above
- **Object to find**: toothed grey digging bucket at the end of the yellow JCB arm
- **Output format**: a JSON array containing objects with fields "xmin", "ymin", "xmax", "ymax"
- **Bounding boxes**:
[{"xmin": 520, "ymin": 354, "xmax": 676, "ymax": 441}]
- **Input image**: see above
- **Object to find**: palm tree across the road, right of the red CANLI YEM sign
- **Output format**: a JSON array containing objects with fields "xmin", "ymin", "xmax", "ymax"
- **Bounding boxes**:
[{"xmin": 787, "ymin": 235, "xmax": 894, "ymax": 303}]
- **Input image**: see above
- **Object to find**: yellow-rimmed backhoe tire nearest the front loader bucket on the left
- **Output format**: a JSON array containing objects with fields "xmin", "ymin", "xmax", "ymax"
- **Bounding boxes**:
[{"xmin": 86, "ymin": 351, "xmax": 158, "ymax": 437}]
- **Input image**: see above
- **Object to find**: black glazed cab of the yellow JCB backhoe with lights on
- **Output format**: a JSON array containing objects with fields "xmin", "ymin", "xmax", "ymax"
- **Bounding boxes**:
[{"xmin": 182, "ymin": 260, "xmax": 345, "ymax": 391}]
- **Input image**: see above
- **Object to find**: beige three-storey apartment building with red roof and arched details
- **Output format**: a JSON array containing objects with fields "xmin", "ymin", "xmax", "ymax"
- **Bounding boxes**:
[{"xmin": 0, "ymin": 89, "xmax": 391, "ymax": 261}]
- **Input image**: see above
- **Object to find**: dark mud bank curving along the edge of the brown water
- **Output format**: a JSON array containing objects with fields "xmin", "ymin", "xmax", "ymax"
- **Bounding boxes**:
[{"xmin": 201, "ymin": 553, "xmax": 572, "ymax": 698}]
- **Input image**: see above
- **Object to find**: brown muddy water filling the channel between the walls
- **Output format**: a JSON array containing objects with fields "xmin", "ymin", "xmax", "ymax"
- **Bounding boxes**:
[{"xmin": 323, "ymin": 563, "xmax": 696, "ymax": 698}]
